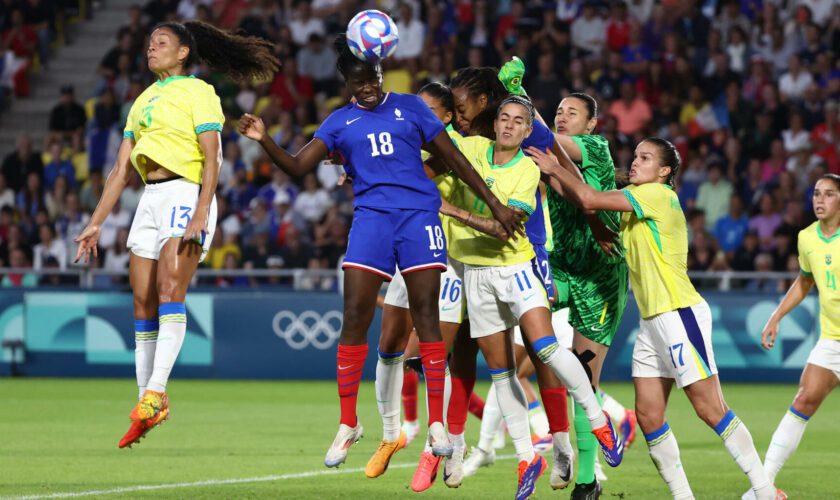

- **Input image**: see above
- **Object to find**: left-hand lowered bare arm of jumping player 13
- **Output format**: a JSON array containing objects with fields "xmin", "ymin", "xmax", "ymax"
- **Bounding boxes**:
[{"xmin": 73, "ymin": 139, "xmax": 134, "ymax": 263}]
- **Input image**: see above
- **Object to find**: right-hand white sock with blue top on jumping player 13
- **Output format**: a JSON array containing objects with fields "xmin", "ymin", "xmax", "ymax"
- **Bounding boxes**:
[{"xmin": 147, "ymin": 302, "xmax": 187, "ymax": 392}]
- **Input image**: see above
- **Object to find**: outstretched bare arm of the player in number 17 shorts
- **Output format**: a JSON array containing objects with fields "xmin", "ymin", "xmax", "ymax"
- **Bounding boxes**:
[{"xmin": 526, "ymin": 148, "xmax": 633, "ymax": 212}]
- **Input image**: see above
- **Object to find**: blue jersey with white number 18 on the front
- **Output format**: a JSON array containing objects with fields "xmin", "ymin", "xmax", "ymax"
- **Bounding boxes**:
[{"xmin": 315, "ymin": 92, "xmax": 444, "ymax": 212}]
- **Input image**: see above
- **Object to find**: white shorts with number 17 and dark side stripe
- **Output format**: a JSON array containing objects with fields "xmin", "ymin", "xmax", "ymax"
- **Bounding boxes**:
[{"xmin": 633, "ymin": 301, "xmax": 717, "ymax": 388}]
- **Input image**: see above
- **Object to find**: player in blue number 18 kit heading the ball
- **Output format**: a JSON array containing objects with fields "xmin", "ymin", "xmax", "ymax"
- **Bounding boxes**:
[{"xmin": 239, "ymin": 35, "xmax": 522, "ymax": 467}]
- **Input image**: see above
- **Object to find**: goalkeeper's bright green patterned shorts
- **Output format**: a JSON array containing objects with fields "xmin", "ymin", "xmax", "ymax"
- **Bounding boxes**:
[{"xmin": 551, "ymin": 260, "xmax": 629, "ymax": 346}]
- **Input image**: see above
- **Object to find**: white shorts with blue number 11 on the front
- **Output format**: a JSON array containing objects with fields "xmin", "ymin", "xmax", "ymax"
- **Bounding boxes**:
[{"xmin": 464, "ymin": 262, "xmax": 548, "ymax": 339}]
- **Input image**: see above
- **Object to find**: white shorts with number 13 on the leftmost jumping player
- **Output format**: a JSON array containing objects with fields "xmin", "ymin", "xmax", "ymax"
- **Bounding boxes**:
[{"xmin": 128, "ymin": 179, "xmax": 216, "ymax": 262}]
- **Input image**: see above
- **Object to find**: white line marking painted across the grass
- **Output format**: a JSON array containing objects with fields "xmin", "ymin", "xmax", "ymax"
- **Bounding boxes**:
[{"xmin": 0, "ymin": 455, "xmax": 516, "ymax": 500}]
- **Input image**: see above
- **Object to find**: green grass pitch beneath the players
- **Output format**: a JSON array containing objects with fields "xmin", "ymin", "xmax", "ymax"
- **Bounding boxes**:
[{"xmin": 0, "ymin": 375, "xmax": 840, "ymax": 499}]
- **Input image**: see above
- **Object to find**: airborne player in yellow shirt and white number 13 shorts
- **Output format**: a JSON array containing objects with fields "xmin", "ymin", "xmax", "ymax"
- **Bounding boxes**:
[{"xmin": 76, "ymin": 22, "xmax": 277, "ymax": 448}]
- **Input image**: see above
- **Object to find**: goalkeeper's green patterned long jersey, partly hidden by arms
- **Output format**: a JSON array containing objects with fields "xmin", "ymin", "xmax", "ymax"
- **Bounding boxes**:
[{"xmin": 548, "ymin": 135, "xmax": 624, "ymax": 275}]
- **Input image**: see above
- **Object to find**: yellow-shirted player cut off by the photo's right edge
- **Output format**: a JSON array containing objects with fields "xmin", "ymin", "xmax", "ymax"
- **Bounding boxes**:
[{"xmin": 743, "ymin": 174, "xmax": 840, "ymax": 500}]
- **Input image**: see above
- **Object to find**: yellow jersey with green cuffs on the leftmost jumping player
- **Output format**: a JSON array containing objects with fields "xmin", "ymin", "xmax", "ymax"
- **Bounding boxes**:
[{"xmin": 123, "ymin": 76, "xmax": 225, "ymax": 184}]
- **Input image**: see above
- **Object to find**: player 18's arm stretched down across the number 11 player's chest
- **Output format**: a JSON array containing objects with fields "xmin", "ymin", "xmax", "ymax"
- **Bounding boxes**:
[{"xmin": 424, "ymin": 131, "xmax": 525, "ymax": 239}]
